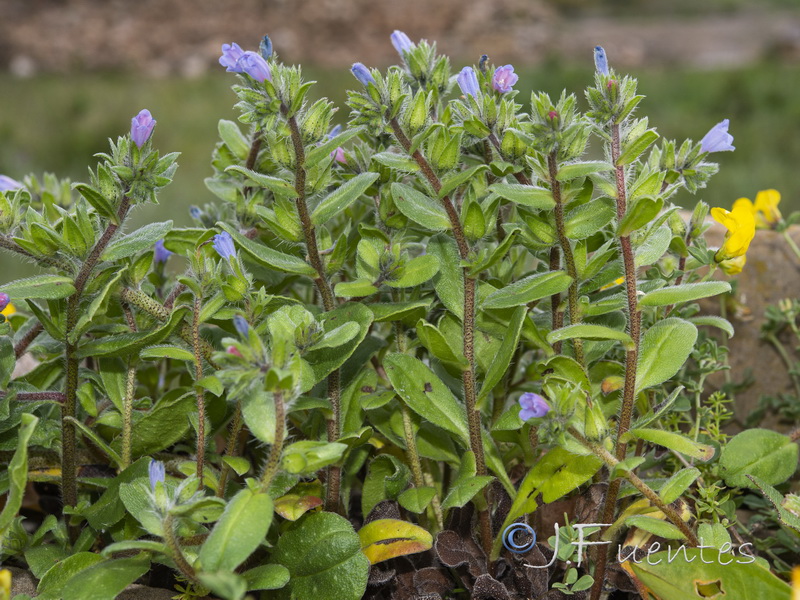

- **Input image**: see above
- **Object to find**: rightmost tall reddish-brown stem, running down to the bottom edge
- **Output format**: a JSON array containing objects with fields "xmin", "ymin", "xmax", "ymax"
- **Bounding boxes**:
[{"xmin": 591, "ymin": 123, "xmax": 641, "ymax": 600}]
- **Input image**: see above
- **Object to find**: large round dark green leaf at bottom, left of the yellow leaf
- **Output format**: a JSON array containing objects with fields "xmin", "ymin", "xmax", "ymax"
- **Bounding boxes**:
[{"xmin": 272, "ymin": 512, "xmax": 370, "ymax": 600}]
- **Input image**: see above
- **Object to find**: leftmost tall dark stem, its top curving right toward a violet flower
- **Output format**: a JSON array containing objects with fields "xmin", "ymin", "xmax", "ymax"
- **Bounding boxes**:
[{"xmin": 61, "ymin": 195, "xmax": 130, "ymax": 506}]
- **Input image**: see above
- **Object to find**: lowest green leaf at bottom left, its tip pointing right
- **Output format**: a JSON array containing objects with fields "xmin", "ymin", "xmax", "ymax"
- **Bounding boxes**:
[{"xmin": 61, "ymin": 556, "xmax": 150, "ymax": 600}]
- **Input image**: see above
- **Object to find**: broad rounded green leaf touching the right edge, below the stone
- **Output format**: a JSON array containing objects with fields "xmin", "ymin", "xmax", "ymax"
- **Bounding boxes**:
[{"xmin": 719, "ymin": 429, "xmax": 798, "ymax": 488}]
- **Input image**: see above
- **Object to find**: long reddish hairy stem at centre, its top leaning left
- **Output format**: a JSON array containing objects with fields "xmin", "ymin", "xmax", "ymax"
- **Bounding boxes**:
[{"xmin": 389, "ymin": 119, "xmax": 492, "ymax": 556}]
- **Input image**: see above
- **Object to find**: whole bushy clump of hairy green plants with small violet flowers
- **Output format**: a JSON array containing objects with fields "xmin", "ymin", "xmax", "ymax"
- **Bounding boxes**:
[{"xmin": 0, "ymin": 31, "xmax": 797, "ymax": 600}]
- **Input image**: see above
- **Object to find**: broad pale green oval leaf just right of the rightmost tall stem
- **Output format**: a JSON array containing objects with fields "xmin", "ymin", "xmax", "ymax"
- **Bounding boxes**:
[{"xmin": 636, "ymin": 318, "xmax": 697, "ymax": 391}]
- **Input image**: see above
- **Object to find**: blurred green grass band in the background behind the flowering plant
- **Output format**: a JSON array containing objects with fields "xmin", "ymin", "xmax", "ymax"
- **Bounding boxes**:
[{"xmin": 0, "ymin": 61, "xmax": 800, "ymax": 283}]
